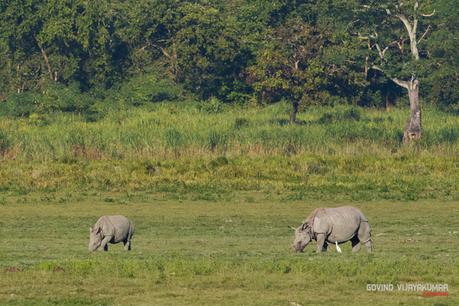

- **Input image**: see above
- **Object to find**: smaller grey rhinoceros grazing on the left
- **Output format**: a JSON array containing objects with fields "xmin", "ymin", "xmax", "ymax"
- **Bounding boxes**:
[{"xmin": 89, "ymin": 216, "xmax": 134, "ymax": 251}]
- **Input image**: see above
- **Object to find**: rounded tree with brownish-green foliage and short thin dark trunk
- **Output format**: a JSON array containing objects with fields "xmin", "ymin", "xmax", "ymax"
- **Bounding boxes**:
[{"xmin": 248, "ymin": 18, "xmax": 327, "ymax": 123}]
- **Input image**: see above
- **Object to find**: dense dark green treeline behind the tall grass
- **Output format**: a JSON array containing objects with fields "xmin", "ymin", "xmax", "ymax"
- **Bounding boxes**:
[{"xmin": 0, "ymin": 0, "xmax": 459, "ymax": 120}]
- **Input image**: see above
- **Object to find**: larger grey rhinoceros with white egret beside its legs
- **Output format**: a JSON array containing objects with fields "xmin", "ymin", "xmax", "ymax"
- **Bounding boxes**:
[{"xmin": 292, "ymin": 206, "xmax": 372, "ymax": 253}]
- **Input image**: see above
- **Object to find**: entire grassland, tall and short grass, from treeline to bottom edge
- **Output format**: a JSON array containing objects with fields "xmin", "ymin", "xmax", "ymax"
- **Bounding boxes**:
[{"xmin": 0, "ymin": 100, "xmax": 459, "ymax": 305}]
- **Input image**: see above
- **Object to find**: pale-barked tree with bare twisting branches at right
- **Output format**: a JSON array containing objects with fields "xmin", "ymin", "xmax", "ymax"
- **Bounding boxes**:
[{"xmin": 358, "ymin": 0, "xmax": 435, "ymax": 143}]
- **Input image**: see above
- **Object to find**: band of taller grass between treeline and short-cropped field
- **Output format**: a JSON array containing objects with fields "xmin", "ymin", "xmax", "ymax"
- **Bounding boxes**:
[{"xmin": 0, "ymin": 103, "xmax": 459, "ymax": 200}]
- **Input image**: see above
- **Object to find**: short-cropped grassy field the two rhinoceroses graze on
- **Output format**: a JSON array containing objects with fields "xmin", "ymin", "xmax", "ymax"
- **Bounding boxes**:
[{"xmin": 0, "ymin": 193, "xmax": 459, "ymax": 305}]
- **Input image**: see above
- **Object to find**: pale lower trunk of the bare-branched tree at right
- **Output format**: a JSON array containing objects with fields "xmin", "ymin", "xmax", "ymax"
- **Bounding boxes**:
[{"xmin": 392, "ymin": 78, "xmax": 422, "ymax": 143}]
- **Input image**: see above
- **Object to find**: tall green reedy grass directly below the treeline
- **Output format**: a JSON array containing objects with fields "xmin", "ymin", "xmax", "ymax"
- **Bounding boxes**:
[{"xmin": 0, "ymin": 103, "xmax": 459, "ymax": 161}]
